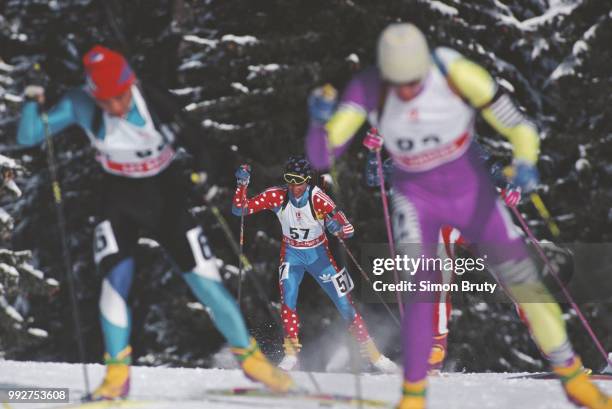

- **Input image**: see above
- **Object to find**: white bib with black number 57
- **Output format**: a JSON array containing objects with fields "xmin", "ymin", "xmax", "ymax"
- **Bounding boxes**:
[{"xmin": 276, "ymin": 186, "xmax": 325, "ymax": 248}]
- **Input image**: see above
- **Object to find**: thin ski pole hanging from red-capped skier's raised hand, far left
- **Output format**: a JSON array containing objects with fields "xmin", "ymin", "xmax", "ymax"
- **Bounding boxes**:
[{"xmin": 42, "ymin": 112, "xmax": 89, "ymax": 396}]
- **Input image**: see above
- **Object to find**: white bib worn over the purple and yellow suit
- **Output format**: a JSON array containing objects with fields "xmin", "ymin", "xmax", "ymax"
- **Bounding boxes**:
[{"xmin": 378, "ymin": 66, "xmax": 475, "ymax": 172}]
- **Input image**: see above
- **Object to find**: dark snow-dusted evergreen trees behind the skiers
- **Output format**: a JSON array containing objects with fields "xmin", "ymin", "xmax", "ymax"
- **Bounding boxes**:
[{"xmin": 0, "ymin": 0, "xmax": 612, "ymax": 371}]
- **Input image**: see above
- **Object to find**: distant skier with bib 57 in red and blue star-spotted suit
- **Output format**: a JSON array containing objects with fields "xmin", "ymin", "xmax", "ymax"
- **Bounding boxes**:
[{"xmin": 232, "ymin": 156, "xmax": 397, "ymax": 373}]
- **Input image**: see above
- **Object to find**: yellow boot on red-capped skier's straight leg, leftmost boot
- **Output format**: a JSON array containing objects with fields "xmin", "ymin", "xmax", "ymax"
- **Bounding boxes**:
[{"xmin": 91, "ymin": 346, "xmax": 132, "ymax": 400}]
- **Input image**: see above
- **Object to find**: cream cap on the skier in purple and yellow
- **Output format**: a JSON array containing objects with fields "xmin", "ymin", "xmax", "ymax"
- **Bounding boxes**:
[{"xmin": 378, "ymin": 23, "xmax": 431, "ymax": 84}]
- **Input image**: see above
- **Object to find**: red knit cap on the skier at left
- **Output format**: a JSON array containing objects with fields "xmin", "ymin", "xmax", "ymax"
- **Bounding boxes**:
[{"xmin": 83, "ymin": 45, "xmax": 136, "ymax": 99}]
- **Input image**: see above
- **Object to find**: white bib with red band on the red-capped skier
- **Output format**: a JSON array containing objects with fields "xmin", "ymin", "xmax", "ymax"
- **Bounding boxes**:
[{"xmin": 89, "ymin": 86, "xmax": 175, "ymax": 178}]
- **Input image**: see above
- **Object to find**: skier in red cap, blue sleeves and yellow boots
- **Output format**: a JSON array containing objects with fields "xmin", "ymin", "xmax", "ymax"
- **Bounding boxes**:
[{"xmin": 17, "ymin": 46, "xmax": 293, "ymax": 399}]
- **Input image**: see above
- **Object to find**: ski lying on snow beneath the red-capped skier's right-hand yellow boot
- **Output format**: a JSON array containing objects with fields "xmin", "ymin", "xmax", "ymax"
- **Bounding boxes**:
[{"xmin": 206, "ymin": 388, "xmax": 393, "ymax": 408}]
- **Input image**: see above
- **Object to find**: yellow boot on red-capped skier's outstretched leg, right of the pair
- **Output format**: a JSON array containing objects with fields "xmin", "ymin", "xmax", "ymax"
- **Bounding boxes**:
[{"xmin": 232, "ymin": 338, "xmax": 295, "ymax": 392}]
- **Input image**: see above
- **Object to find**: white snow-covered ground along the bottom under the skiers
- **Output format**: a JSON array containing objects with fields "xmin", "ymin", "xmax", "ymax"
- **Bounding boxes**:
[{"xmin": 0, "ymin": 361, "xmax": 612, "ymax": 409}]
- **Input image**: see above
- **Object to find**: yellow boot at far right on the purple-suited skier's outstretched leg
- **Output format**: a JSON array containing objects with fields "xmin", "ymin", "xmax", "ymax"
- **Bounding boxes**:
[{"xmin": 553, "ymin": 357, "xmax": 612, "ymax": 409}]
